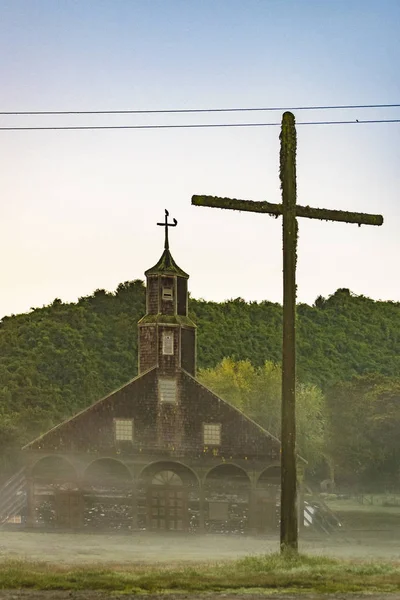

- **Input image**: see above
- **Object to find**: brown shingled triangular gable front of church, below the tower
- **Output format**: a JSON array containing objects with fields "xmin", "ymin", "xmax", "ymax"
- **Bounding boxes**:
[{"xmin": 24, "ymin": 368, "xmax": 300, "ymax": 460}]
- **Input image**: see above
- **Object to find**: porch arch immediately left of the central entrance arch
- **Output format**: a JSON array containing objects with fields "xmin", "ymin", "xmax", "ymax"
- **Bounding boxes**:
[{"xmin": 83, "ymin": 458, "xmax": 134, "ymax": 531}]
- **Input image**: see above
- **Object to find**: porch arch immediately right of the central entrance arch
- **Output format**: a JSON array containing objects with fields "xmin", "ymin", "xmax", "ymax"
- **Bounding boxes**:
[{"xmin": 204, "ymin": 464, "xmax": 250, "ymax": 533}]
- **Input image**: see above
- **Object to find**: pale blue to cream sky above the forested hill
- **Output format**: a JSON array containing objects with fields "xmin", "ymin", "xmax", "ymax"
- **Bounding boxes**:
[{"xmin": 0, "ymin": 0, "xmax": 400, "ymax": 316}]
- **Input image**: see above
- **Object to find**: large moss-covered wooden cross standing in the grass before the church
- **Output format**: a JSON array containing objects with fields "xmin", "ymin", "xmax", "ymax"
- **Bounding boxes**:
[{"xmin": 192, "ymin": 112, "xmax": 383, "ymax": 552}]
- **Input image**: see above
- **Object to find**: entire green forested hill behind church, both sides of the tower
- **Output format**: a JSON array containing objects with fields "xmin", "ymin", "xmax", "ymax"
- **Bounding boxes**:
[{"xmin": 0, "ymin": 280, "xmax": 400, "ymax": 472}]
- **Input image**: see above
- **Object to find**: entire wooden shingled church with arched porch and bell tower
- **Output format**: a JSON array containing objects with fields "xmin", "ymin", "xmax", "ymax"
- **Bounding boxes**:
[{"xmin": 24, "ymin": 211, "xmax": 280, "ymax": 533}]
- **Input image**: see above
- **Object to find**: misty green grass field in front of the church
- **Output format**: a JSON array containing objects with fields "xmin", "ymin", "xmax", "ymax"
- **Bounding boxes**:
[{"xmin": 0, "ymin": 500, "xmax": 400, "ymax": 600}]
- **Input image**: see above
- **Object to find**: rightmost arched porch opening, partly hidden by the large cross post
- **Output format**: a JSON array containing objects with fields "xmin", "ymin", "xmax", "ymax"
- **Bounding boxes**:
[{"xmin": 256, "ymin": 465, "xmax": 281, "ymax": 533}]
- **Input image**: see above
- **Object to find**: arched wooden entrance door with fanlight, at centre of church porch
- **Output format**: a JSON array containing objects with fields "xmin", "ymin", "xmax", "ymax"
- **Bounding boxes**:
[{"xmin": 148, "ymin": 471, "xmax": 188, "ymax": 531}]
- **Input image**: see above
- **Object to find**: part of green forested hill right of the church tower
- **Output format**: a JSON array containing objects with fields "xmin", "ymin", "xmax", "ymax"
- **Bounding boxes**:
[{"xmin": 191, "ymin": 289, "xmax": 400, "ymax": 389}]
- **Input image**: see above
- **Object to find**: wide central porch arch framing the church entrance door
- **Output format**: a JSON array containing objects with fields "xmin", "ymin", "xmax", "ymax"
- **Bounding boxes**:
[{"xmin": 138, "ymin": 462, "xmax": 199, "ymax": 531}]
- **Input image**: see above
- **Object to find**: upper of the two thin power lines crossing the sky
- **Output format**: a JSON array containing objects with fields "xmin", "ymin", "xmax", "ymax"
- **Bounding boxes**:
[{"xmin": 0, "ymin": 104, "xmax": 400, "ymax": 116}]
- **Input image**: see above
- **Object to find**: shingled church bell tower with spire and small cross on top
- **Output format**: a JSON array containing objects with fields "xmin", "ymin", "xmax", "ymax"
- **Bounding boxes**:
[{"xmin": 138, "ymin": 210, "xmax": 196, "ymax": 376}]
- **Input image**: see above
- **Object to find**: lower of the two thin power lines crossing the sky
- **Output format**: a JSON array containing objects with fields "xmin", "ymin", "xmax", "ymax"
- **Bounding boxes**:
[{"xmin": 0, "ymin": 119, "xmax": 400, "ymax": 131}]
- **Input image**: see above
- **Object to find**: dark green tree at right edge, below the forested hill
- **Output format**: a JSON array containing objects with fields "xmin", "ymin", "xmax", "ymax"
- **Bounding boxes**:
[{"xmin": 327, "ymin": 375, "xmax": 400, "ymax": 491}]
